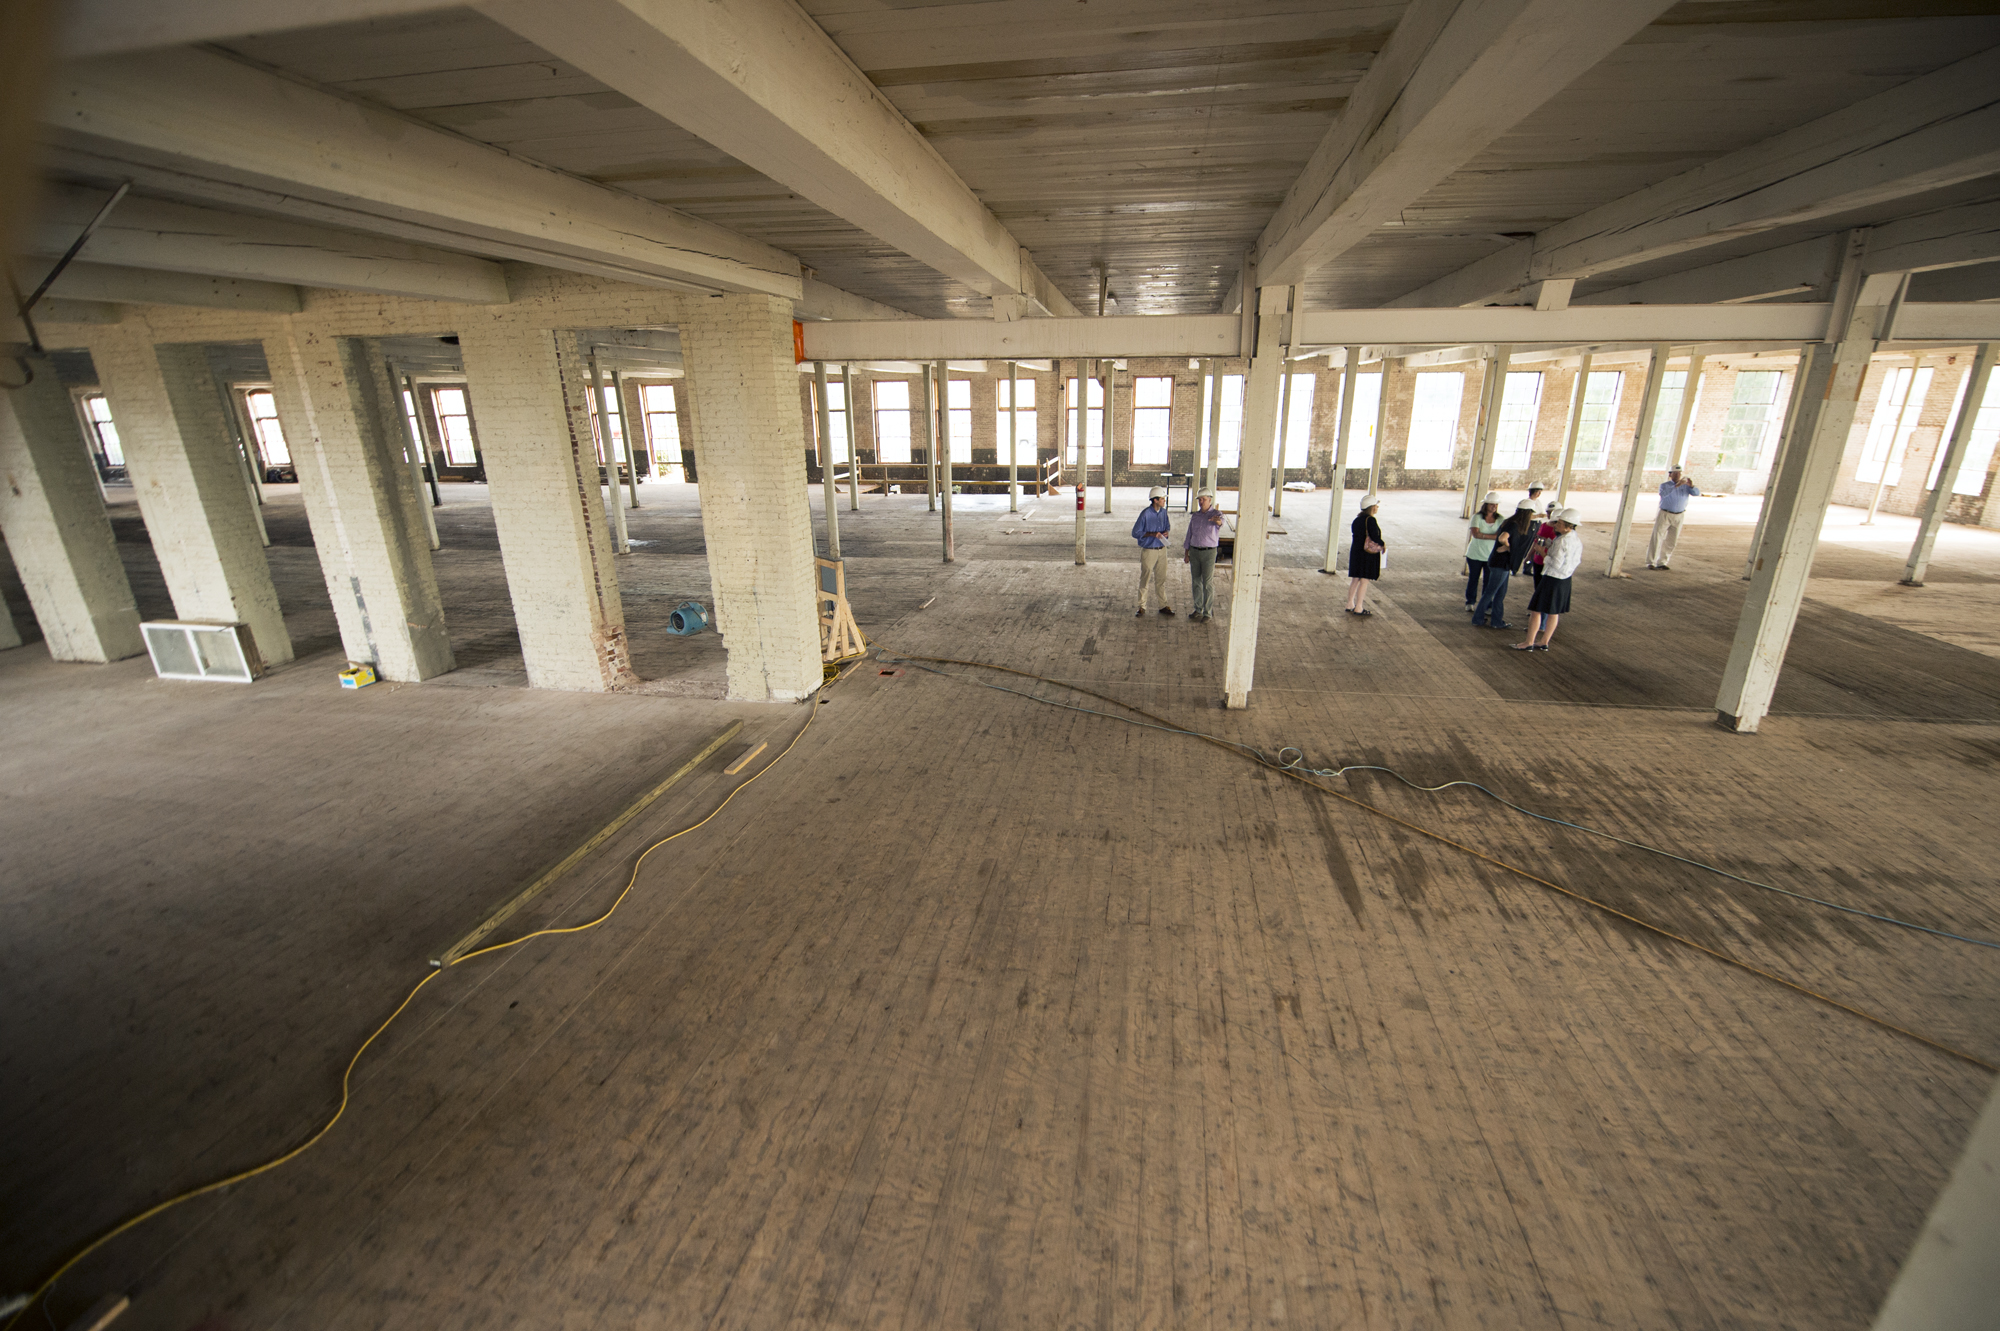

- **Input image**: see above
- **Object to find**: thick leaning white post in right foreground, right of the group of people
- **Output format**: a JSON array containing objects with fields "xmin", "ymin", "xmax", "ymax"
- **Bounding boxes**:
[{"xmin": 1716, "ymin": 265, "xmax": 1908, "ymax": 733}]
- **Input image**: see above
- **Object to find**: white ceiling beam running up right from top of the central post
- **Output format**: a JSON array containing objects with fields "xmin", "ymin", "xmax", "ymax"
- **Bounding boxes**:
[{"xmin": 1258, "ymin": 0, "xmax": 1672, "ymax": 286}]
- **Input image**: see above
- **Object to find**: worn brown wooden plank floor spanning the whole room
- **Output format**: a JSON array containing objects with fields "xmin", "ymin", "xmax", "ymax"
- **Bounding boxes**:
[{"xmin": 0, "ymin": 481, "xmax": 2000, "ymax": 1331}]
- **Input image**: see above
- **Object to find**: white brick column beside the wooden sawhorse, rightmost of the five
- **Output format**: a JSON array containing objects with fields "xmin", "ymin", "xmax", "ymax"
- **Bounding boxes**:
[{"xmin": 680, "ymin": 296, "xmax": 820, "ymax": 701}]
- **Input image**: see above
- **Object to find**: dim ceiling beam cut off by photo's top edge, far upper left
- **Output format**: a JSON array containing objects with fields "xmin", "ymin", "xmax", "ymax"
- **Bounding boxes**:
[{"xmin": 58, "ymin": 0, "xmax": 450, "ymax": 60}]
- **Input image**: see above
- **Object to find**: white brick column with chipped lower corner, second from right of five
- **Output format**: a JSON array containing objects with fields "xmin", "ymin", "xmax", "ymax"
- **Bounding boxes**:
[{"xmin": 458, "ymin": 322, "xmax": 634, "ymax": 691}]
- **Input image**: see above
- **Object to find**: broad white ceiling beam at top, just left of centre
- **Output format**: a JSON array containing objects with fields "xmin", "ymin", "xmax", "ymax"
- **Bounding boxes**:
[{"xmin": 478, "ymin": 0, "xmax": 1080, "ymax": 314}]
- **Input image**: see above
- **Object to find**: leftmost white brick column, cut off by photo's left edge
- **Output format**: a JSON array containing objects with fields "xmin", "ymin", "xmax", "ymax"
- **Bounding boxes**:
[{"xmin": 0, "ymin": 360, "xmax": 145, "ymax": 662}]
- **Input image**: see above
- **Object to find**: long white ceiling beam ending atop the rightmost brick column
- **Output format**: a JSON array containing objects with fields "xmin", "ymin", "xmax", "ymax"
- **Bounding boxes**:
[{"xmin": 42, "ymin": 48, "xmax": 802, "ymax": 300}]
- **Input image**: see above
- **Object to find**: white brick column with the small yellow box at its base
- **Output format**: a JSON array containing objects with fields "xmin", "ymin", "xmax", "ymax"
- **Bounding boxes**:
[{"xmin": 264, "ymin": 328, "xmax": 452, "ymax": 683}]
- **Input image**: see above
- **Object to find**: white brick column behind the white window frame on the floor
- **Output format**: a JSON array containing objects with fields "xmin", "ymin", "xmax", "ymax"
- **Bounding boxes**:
[{"xmin": 90, "ymin": 324, "xmax": 292, "ymax": 666}]
